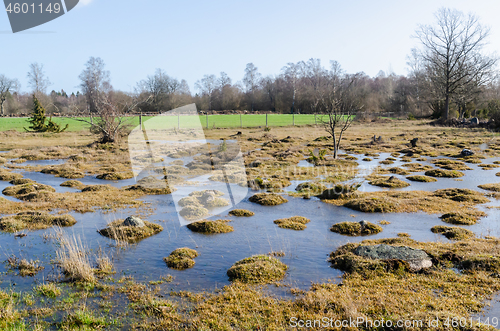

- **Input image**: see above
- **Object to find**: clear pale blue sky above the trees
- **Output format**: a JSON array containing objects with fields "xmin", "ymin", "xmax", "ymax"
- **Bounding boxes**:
[{"xmin": 0, "ymin": 0, "xmax": 500, "ymax": 92}]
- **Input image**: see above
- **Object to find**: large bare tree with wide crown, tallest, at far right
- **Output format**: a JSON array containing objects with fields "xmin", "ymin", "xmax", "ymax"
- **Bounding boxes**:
[{"xmin": 416, "ymin": 8, "xmax": 497, "ymax": 119}]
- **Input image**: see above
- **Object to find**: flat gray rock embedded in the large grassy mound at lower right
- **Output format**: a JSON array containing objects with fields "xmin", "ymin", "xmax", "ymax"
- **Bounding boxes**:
[{"xmin": 354, "ymin": 244, "xmax": 432, "ymax": 271}]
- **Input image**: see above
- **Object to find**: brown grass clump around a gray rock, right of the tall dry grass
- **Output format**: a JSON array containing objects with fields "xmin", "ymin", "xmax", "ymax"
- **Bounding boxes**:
[{"xmin": 97, "ymin": 220, "xmax": 163, "ymax": 243}]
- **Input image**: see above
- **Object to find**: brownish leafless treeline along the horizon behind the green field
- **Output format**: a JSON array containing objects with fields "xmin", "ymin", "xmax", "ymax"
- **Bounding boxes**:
[{"xmin": 0, "ymin": 59, "xmax": 500, "ymax": 118}]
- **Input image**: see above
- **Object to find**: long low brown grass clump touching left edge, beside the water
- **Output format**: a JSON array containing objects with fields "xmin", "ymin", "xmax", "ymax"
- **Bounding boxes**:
[{"xmin": 0, "ymin": 211, "xmax": 76, "ymax": 232}]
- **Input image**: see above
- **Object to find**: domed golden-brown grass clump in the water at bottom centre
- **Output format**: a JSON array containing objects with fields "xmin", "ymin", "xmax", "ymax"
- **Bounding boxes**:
[{"xmin": 227, "ymin": 255, "xmax": 288, "ymax": 284}]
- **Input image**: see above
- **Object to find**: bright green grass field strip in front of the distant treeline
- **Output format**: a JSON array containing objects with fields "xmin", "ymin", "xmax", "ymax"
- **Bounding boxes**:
[{"xmin": 0, "ymin": 114, "xmax": 321, "ymax": 131}]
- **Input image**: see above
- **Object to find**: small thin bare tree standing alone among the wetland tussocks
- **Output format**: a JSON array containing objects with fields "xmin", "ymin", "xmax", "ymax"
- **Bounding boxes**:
[{"xmin": 321, "ymin": 72, "xmax": 363, "ymax": 159}]
